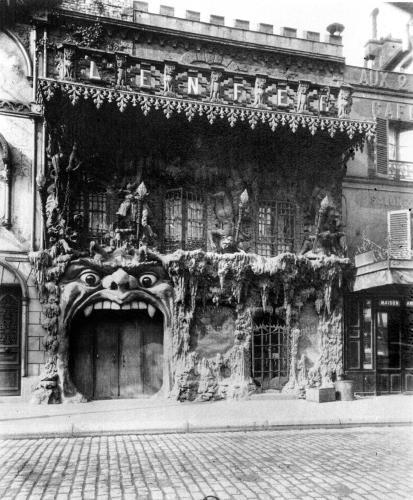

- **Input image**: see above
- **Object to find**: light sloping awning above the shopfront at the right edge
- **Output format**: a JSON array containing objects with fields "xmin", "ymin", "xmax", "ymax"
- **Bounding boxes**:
[{"xmin": 353, "ymin": 260, "xmax": 413, "ymax": 292}]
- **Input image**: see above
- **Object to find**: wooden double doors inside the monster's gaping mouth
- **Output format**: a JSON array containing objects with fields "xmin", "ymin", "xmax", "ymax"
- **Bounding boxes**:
[{"xmin": 69, "ymin": 312, "xmax": 163, "ymax": 399}]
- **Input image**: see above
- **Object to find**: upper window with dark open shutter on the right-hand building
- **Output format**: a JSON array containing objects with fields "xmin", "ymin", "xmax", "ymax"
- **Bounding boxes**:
[{"xmin": 376, "ymin": 118, "xmax": 413, "ymax": 181}]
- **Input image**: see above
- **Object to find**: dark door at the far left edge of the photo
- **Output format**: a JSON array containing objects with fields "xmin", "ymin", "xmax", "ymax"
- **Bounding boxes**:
[{"xmin": 0, "ymin": 286, "xmax": 21, "ymax": 396}]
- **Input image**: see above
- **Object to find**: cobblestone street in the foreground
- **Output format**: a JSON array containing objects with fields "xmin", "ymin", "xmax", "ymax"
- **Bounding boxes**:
[{"xmin": 0, "ymin": 427, "xmax": 413, "ymax": 500}]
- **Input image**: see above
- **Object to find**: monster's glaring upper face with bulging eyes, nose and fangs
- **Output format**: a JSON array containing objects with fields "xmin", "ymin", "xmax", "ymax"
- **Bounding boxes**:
[{"xmin": 60, "ymin": 259, "xmax": 172, "ymax": 325}]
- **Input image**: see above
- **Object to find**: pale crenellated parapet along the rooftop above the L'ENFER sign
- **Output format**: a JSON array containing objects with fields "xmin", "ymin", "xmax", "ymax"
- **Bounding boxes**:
[{"xmin": 62, "ymin": 0, "xmax": 344, "ymax": 59}]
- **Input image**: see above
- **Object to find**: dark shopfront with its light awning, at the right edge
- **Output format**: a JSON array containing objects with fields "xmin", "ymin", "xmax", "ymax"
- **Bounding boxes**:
[{"xmin": 345, "ymin": 261, "xmax": 413, "ymax": 394}]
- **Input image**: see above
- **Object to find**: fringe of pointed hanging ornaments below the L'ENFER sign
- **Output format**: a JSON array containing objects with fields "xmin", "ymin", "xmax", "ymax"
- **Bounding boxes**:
[{"xmin": 38, "ymin": 78, "xmax": 376, "ymax": 140}]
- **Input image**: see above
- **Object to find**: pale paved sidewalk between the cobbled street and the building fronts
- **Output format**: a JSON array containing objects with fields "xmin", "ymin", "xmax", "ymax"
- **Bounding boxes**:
[{"xmin": 0, "ymin": 395, "xmax": 413, "ymax": 438}]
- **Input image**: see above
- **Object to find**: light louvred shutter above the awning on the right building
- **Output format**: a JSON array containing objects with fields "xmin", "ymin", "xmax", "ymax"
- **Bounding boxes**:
[{"xmin": 387, "ymin": 210, "xmax": 411, "ymax": 259}]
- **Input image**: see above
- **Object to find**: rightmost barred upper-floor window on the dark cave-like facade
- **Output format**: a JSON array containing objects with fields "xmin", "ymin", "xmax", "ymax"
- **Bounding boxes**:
[{"xmin": 256, "ymin": 201, "xmax": 300, "ymax": 257}]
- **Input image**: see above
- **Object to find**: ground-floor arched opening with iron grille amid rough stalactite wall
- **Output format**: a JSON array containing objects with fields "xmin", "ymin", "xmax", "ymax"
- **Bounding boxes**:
[{"xmin": 251, "ymin": 317, "xmax": 288, "ymax": 390}]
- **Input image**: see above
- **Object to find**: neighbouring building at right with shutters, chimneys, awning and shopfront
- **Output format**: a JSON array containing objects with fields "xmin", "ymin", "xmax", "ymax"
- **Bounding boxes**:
[{"xmin": 343, "ymin": 2, "xmax": 413, "ymax": 394}]
